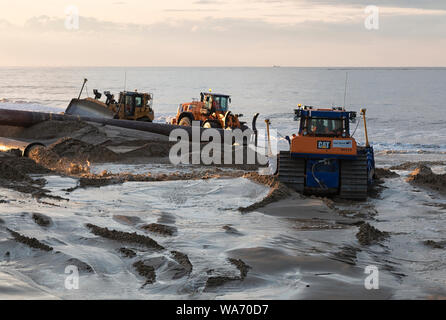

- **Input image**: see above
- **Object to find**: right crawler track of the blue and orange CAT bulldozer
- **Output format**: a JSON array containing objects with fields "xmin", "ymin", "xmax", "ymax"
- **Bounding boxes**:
[{"xmin": 339, "ymin": 155, "xmax": 368, "ymax": 200}]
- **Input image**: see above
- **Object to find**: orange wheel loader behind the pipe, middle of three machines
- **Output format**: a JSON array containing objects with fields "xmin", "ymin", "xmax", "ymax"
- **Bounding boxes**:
[{"xmin": 171, "ymin": 91, "xmax": 248, "ymax": 130}]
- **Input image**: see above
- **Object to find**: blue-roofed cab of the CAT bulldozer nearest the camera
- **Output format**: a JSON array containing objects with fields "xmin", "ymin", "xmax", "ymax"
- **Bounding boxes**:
[{"xmin": 295, "ymin": 106, "xmax": 356, "ymax": 138}]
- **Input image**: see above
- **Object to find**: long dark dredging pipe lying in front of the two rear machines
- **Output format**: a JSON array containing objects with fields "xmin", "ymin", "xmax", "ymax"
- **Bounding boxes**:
[{"xmin": 0, "ymin": 109, "xmax": 244, "ymax": 139}]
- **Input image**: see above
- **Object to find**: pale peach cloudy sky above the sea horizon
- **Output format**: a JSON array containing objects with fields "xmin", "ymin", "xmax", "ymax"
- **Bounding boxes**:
[{"xmin": 0, "ymin": 0, "xmax": 446, "ymax": 67}]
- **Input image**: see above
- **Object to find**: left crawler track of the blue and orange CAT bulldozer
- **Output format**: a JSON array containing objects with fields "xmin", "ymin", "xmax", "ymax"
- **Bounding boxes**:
[{"xmin": 277, "ymin": 151, "xmax": 305, "ymax": 193}]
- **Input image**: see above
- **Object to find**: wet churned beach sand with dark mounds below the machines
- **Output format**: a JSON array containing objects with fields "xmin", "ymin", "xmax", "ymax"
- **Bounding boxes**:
[{"xmin": 0, "ymin": 122, "xmax": 446, "ymax": 299}]
